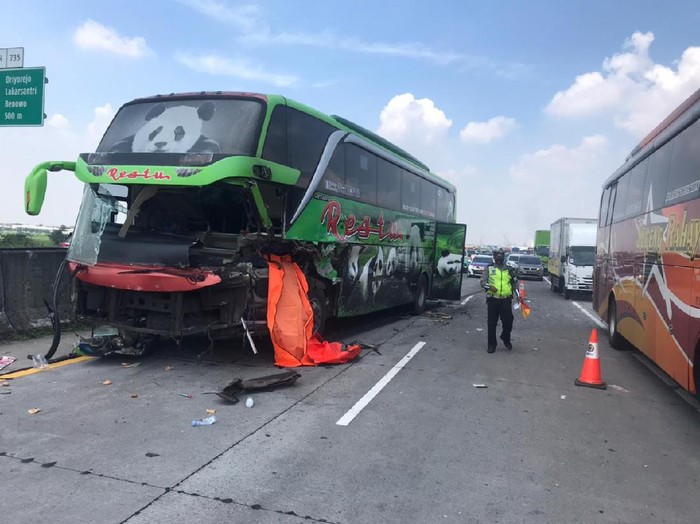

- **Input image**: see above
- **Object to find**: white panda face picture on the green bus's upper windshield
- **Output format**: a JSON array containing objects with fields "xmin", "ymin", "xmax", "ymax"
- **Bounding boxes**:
[{"xmin": 131, "ymin": 102, "xmax": 214, "ymax": 153}]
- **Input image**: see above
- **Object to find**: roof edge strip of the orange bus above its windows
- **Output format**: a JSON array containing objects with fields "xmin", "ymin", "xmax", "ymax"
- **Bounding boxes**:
[{"xmin": 603, "ymin": 89, "xmax": 700, "ymax": 188}]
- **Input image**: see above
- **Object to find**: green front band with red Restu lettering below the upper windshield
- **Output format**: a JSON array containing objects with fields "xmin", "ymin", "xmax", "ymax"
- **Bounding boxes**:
[{"xmin": 75, "ymin": 156, "xmax": 300, "ymax": 186}]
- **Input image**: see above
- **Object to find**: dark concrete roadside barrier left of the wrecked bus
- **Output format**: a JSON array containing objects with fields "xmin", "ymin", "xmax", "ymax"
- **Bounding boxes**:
[{"xmin": 0, "ymin": 248, "xmax": 75, "ymax": 335}]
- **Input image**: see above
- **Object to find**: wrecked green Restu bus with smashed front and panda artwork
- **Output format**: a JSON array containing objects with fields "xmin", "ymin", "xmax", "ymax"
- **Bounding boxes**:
[{"xmin": 25, "ymin": 92, "xmax": 466, "ymax": 354}]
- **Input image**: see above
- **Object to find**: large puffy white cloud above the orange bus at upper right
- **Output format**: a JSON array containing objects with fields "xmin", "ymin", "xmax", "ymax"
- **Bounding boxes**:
[{"xmin": 546, "ymin": 32, "xmax": 700, "ymax": 137}]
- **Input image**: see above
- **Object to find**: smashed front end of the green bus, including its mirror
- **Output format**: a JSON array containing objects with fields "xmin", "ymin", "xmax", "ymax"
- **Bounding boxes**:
[{"xmin": 25, "ymin": 95, "xmax": 299, "ymax": 352}]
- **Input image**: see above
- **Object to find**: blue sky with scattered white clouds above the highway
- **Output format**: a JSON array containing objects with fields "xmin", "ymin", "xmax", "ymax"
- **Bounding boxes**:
[{"xmin": 0, "ymin": 0, "xmax": 700, "ymax": 245}]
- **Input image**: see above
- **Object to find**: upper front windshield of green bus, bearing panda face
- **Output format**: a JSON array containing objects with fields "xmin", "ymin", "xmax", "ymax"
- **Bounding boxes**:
[{"xmin": 97, "ymin": 98, "xmax": 265, "ymax": 156}]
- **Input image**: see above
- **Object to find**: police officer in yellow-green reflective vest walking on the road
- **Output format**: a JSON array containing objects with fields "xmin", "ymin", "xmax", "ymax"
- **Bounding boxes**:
[{"xmin": 481, "ymin": 248, "xmax": 517, "ymax": 353}]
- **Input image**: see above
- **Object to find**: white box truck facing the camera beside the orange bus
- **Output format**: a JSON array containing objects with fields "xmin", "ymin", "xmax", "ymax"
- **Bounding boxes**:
[{"xmin": 547, "ymin": 217, "xmax": 598, "ymax": 300}]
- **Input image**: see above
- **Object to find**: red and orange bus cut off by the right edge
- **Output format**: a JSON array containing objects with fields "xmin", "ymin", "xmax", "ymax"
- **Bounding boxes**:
[{"xmin": 593, "ymin": 90, "xmax": 700, "ymax": 394}]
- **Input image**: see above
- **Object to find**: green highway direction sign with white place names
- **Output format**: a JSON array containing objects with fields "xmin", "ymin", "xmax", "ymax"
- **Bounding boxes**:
[{"xmin": 0, "ymin": 67, "xmax": 46, "ymax": 127}]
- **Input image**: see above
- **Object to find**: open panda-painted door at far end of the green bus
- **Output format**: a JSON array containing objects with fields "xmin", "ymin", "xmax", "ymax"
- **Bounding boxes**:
[{"xmin": 429, "ymin": 222, "xmax": 467, "ymax": 300}]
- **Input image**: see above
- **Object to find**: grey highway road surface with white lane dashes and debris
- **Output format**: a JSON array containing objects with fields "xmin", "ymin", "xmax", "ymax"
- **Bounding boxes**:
[{"xmin": 0, "ymin": 277, "xmax": 700, "ymax": 524}]
